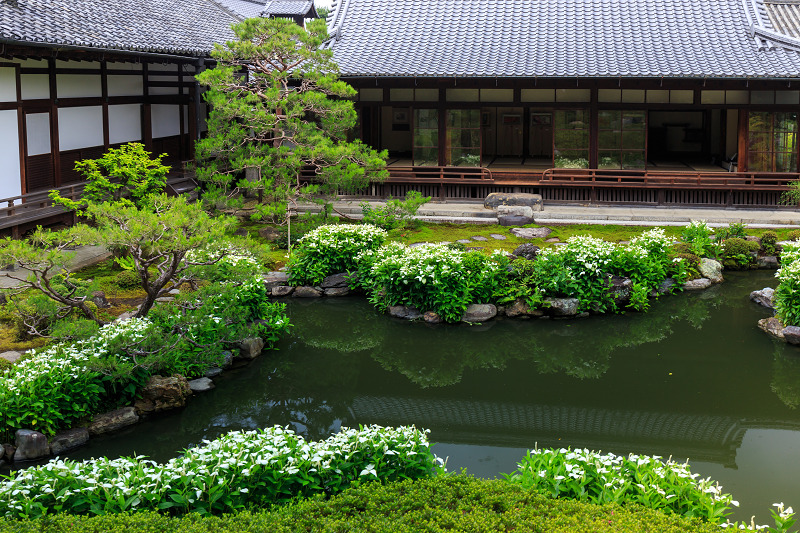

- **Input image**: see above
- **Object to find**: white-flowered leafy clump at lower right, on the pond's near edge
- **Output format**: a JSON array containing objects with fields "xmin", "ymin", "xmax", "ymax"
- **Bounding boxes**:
[{"xmin": 506, "ymin": 448, "xmax": 739, "ymax": 523}]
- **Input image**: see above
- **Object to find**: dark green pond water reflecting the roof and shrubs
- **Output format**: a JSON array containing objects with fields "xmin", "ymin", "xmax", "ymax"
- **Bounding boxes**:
[{"xmin": 70, "ymin": 271, "xmax": 800, "ymax": 523}]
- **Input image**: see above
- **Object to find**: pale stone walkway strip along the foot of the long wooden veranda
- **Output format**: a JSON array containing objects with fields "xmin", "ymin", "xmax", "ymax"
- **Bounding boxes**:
[{"xmin": 299, "ymin": 200, "xmax": 800, "ymax": 228}]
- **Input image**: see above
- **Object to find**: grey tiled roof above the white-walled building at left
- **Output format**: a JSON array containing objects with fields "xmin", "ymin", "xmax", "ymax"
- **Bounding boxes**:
[{"xmin": 0, "ymin": 0, "xmax": 238, "ymax": 57}]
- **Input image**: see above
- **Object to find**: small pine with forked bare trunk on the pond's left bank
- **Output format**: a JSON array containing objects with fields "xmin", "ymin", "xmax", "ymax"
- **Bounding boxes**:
[{"xmin": 84, "ymin": 195, "xmax": 236, "ymax": 317}]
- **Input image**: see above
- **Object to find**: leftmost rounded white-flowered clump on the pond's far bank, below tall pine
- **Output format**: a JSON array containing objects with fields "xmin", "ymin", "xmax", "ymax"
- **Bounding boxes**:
[{"xmin": 287, "ymin": 224, "xmax": 386, "ymax": 285}]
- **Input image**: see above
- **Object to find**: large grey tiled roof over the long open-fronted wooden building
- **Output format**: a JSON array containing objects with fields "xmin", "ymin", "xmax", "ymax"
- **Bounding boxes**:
[{"xmin": 328, "ymin": 0, "xmax": 800, "ymax": 78}]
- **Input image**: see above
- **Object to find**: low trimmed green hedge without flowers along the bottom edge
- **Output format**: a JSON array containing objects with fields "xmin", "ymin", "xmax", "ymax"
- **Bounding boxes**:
[{"xmin": 0, "ymin": 475, "xmax": 720, "ymax": 533}]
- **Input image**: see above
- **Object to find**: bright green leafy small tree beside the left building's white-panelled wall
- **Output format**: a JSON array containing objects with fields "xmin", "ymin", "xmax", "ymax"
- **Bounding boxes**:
[{"xmin": 50, "ymin": 143, "xmax": 170, "ymax": 211}]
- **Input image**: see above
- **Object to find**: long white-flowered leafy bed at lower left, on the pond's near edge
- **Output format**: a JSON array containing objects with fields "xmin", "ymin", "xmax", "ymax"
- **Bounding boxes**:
[{"xmin": 0, "ymin": 426, "xmax": 444, "ymax": 518}]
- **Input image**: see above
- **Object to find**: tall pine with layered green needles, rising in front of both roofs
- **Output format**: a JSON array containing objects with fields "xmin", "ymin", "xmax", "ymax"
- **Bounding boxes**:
[{"xmin": 196, "ymin": 18, "xmax": 387, "ymax": 218}]
